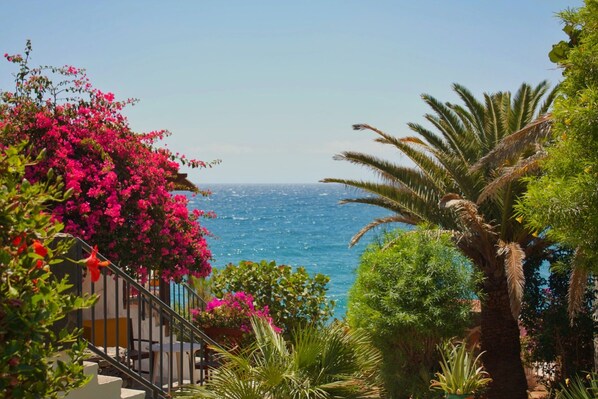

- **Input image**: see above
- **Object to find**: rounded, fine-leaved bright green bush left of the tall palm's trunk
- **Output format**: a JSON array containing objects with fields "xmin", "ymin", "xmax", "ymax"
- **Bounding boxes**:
[{"xmin": 347, "ymin": 229, "xmax": 474, "ymax": 398}]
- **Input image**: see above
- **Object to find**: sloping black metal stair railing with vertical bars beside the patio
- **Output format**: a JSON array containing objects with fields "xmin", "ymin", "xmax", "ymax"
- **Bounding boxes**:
[{"xmin": 70, "ymin": 239, "xmax": 219, "ymax": 398}]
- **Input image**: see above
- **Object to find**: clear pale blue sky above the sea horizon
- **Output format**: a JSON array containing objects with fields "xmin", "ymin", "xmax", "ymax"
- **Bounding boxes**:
[{"xmin": 0, "ymin": 0, "xmax": 582, "ymax": 185}]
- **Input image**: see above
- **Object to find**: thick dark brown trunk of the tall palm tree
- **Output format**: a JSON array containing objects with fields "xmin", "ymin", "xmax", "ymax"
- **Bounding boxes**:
[{"xmin": 481, "ymin": 275, "xmax": 527, "ymax": 399}]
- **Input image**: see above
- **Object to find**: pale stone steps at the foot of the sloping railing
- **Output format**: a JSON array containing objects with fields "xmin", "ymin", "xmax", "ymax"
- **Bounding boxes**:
[{"xmin": 65, "ymin": 362, "xmax": 145, "ymax": 399}]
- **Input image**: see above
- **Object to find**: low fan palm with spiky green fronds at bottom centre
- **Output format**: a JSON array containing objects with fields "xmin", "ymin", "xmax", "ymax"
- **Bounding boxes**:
[{"xmin": 179, "ymin": 318, "xmax": 381, "ymax": 399}]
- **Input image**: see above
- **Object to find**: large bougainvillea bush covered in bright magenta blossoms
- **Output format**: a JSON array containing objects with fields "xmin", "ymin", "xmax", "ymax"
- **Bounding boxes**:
[{"xmin": 0, "ymin": 43, "xmax": 211, "ymax": 280}]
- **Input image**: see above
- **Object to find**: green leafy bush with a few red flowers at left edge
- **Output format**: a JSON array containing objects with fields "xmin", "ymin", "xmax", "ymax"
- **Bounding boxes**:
[{"xmin": 0, "ymin": 145, "xmax": 92, "ymax": 398}]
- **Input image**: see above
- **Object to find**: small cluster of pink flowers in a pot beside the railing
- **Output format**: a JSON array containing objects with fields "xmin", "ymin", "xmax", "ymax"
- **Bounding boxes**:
[{"xmin": 191, "ymin": 291, "xmax": 281, "ymax": 333}]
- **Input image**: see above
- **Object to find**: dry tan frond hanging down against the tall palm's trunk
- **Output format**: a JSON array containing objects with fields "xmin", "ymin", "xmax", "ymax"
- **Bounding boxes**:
[{"xmin": 497, "ymin": 240, "xmax": 525, "ymax": 320}]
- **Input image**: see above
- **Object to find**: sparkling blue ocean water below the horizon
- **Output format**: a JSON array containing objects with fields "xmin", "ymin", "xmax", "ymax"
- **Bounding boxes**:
[{"xmin": 190, "ymin": 183, "xmax": 398, "ymax": 318}]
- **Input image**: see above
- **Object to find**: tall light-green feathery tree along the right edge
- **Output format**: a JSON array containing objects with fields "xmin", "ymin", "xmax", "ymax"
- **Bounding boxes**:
[{"xmin": 519, "ymin": 0, "xmax": 598, "ymax": 314}]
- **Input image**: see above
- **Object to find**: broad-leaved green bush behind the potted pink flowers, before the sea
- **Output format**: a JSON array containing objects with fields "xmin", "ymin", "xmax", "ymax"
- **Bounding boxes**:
[{"xmin": 211, "ymin": 260, "xmax": 334, "ymax": 333}]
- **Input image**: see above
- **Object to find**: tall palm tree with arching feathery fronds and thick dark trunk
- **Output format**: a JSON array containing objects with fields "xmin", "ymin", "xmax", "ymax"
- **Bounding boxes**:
[{"xmin": 323, "ymin": 82, "xmax": 555, "ymax": 399}]
